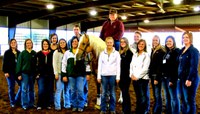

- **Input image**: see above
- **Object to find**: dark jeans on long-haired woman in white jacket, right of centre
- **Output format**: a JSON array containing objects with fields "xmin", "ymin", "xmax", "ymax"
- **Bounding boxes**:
[{"xmin": 133, "ymin": 79, "xmax": 150, "ymax": 114}]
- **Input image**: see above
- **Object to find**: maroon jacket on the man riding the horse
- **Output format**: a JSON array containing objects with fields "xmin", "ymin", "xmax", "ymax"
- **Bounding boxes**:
[{"xmin": 99, "ymin": 19, "xmax": 124, "ymax": 41}]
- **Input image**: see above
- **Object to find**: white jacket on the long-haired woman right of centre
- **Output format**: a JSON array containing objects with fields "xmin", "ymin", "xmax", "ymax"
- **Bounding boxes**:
[{"xmin": 130, "ymin": 52, "xmax": 150, "ymax": 79}]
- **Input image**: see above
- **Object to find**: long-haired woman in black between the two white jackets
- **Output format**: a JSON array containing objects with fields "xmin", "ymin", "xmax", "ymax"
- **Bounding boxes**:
[{"xmin": 119, "ymin": 38, "xmax": 133, "ymax": 114}]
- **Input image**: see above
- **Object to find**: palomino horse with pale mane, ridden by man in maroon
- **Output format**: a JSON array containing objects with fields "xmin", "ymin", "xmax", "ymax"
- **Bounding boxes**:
[{"xmin": 76, "ymin": 34, "xmax": 106, "ymax": 108}]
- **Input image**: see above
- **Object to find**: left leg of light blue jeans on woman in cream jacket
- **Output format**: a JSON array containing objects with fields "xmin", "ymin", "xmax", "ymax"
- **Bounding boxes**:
[{"xmin": 54, "ymin": 75, "xmax": 65, "ymax": 109}]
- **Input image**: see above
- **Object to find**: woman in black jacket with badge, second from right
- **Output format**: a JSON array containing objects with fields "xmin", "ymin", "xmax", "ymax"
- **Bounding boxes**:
[{"xmin": 162, "ymin": 36, "xmax": 180, "ymax": 114}]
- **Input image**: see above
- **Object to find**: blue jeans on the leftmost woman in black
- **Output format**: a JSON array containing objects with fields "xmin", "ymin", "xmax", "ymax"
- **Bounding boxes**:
[{"xmin": 6, "ymin": 74, "xmax": 21, "ymax": 105}]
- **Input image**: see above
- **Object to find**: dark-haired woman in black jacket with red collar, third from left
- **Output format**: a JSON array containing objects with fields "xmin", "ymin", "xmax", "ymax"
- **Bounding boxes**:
[{"xmin": 36, "ymin": 39, "xmax": 54, "ymax": 110}]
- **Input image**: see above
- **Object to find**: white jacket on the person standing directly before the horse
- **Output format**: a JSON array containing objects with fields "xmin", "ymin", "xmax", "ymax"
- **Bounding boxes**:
[{"xmin": 97, "ymin": 48, "xmax": 121, "ymax": 80}]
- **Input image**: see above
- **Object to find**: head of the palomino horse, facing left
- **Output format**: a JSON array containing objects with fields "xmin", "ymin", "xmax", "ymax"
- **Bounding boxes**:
[{"xmin": 76, "ymin": 34, "xmax": 91, "ymax": 60}]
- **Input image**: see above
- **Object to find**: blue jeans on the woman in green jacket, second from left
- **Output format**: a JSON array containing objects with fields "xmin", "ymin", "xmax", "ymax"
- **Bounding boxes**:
[{"xmin": 21, "ymin": 73, "xmax": 35, "ymax": 108}]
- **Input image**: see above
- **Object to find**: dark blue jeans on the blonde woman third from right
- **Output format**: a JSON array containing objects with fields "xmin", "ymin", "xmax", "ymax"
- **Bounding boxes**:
[{"xmin": 151, "ymin": 78, "xmax": 162, "ymax": 114}]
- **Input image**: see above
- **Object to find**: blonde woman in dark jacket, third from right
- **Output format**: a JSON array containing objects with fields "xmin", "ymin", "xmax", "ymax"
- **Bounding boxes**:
[{"xmin": 149, "ymin": 35, "xmax": 165, "ymax": 114}]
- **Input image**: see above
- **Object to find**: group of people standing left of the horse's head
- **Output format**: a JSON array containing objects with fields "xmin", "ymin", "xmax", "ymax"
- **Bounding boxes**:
[{"xmin": 3, "ymin": 25, "xmax": 89, "ymax": 112}]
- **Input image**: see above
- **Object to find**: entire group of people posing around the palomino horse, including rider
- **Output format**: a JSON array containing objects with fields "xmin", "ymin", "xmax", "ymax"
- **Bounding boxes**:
[{"xmin": 3, "ymin": 10, "xmax": 199, "ymax": 114}]
